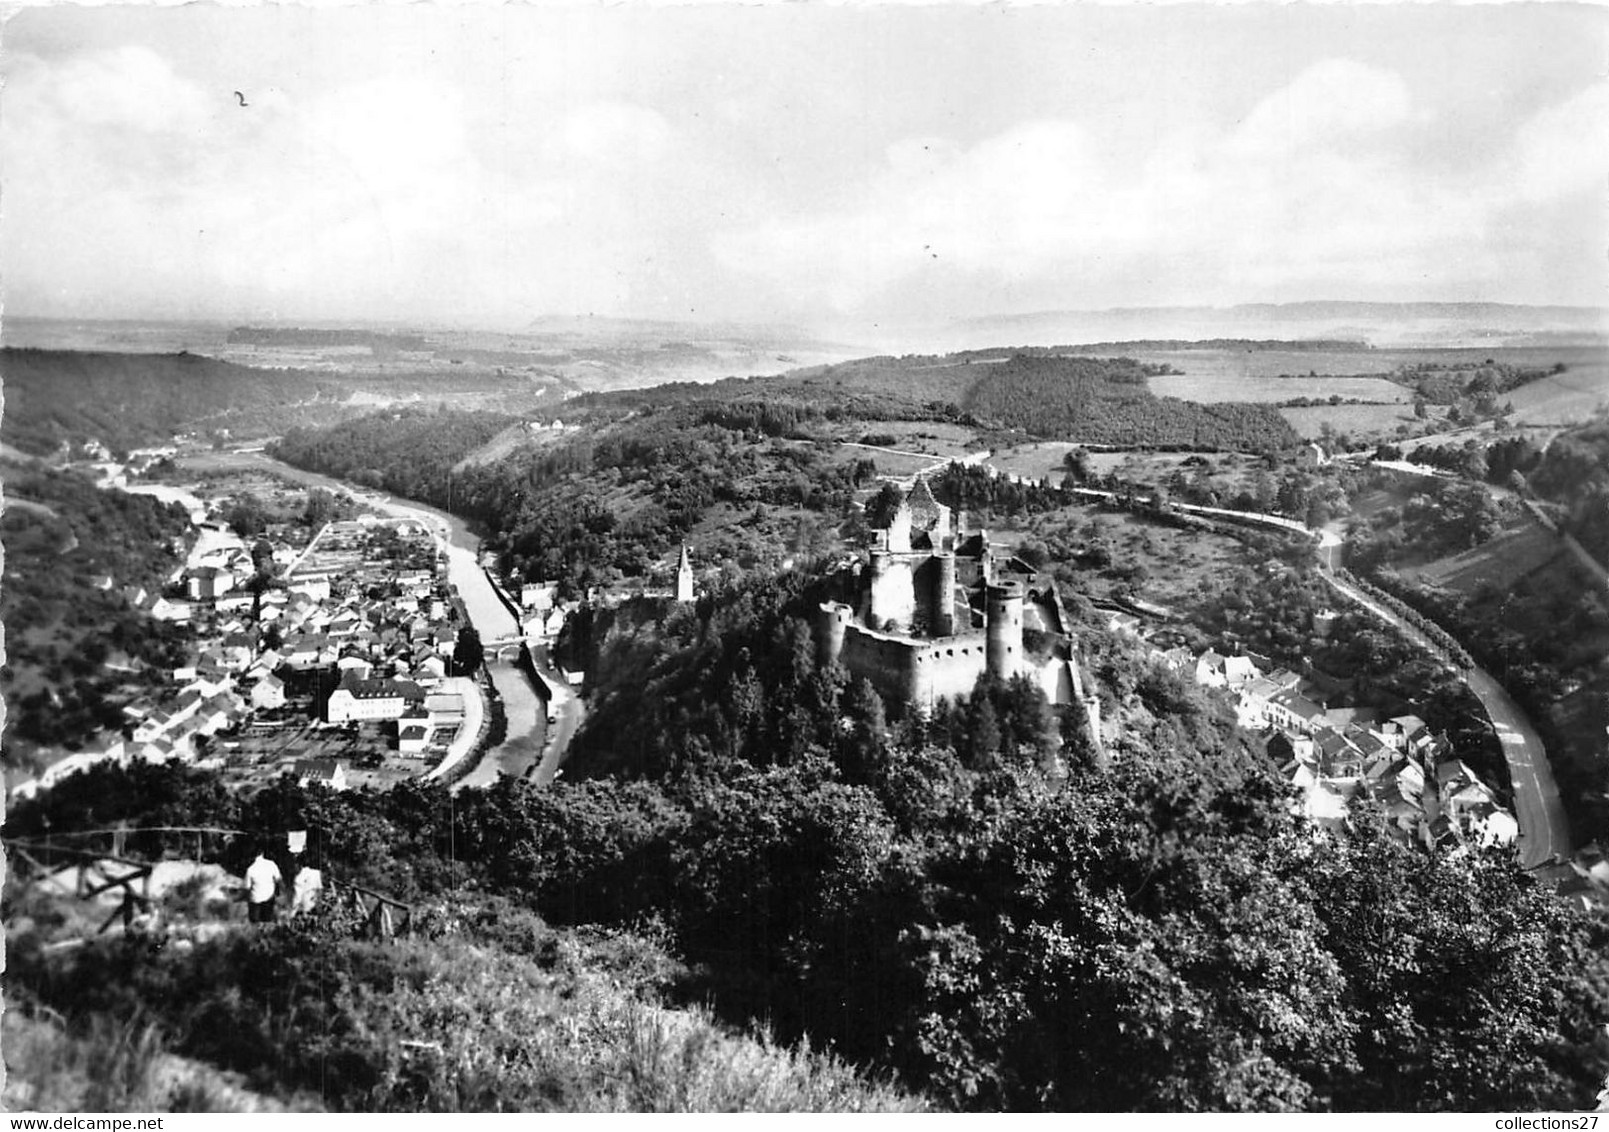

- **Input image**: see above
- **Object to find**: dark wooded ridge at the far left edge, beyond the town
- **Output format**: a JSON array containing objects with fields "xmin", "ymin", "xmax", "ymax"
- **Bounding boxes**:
[{"xmin": 0, "ymin": 347, "xmax": 346, "ymax": 455}]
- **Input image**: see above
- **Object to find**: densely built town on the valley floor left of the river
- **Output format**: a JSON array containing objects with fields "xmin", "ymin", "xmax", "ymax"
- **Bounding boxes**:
[{"xmin": 11, "ymin": 456, "xmax": 550, "ymax": 798}]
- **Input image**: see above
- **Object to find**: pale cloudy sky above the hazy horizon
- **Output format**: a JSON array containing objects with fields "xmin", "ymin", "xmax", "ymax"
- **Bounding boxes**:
[{"xmin": 0, "ymin": 2, "xmax": 1609, "ymax": 328}]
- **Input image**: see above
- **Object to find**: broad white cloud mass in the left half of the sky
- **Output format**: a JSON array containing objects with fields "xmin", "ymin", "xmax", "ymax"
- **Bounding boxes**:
[{"xmin": 0, "ymin": 48, "xmax": 701, "ymax": 318}]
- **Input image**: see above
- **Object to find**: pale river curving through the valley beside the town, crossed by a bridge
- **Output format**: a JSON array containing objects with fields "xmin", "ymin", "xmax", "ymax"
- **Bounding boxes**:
[{"xmin": 213, "ymin": 452, "xmax": 547, "ymax": 786}]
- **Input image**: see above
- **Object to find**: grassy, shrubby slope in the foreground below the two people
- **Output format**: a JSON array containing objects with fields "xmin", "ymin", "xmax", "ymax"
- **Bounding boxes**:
[{"xmin": 6, "ymin": 907, "xmax": 922, "ymax": 1113}]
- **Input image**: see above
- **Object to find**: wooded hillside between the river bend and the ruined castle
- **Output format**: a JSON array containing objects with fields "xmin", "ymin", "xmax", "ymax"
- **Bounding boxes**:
[{"xmin": 274, "ymin": 402, "xmax": 875, "ymax": 592}]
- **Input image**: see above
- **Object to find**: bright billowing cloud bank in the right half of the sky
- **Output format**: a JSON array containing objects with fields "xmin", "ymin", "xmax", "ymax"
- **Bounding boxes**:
[{"xmin": 714, "ymin": 59, "xmax": 1609, "ymax": 314}]
